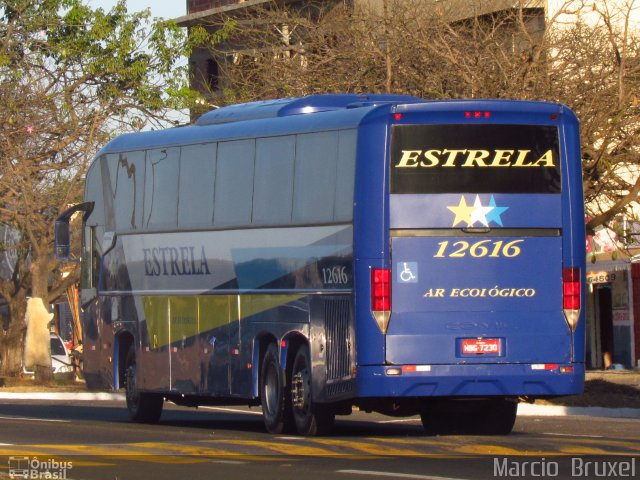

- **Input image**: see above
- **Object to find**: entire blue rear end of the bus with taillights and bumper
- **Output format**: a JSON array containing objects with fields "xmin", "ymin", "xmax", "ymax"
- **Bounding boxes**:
[{"xmin": 358, "ymin": 101, "xmax": 584, "ymax": 403}]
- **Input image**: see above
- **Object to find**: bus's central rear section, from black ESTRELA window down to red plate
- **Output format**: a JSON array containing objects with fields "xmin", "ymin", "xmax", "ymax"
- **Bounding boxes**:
[{"xmin": 386, "ymin": 124, "xmax": 572, "ymax": 365}]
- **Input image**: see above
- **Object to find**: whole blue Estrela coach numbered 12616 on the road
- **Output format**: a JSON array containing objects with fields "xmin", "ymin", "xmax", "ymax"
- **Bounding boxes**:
[{"xmin": 56, "ymin": 94, "xmax": 585, "ymax": 435}]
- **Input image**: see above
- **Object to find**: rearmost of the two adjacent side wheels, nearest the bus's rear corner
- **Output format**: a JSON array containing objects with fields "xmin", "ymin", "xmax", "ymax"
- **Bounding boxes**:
[{"xmin": 291, "ymin": 345, "xmax": 335, "ymax": 436}]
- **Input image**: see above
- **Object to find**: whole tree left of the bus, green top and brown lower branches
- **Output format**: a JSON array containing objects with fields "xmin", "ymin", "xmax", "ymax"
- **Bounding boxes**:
[{"xmin": 0, "ymin": 0, "xmax": 195, "ymax": 376}]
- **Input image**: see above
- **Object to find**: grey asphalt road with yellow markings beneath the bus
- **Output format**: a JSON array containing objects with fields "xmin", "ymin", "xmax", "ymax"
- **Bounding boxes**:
[{"xmin": 0, "ymin": 400, "xmax": 640, "ymax": 480}]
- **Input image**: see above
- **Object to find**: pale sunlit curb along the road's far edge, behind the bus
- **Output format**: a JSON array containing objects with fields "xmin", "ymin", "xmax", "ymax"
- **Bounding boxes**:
[{"xmin": 0, "ymin": 392, "xmax": 640, "ymax": 419}]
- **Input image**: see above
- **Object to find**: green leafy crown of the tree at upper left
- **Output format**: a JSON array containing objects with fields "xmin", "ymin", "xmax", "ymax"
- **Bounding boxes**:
[{"xmin": 0, "ymin": 0, "xmax": 195, "ymax": 116}]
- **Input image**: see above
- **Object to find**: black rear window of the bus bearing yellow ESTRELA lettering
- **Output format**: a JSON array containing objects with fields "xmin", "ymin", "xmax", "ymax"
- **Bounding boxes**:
[{"xmin": 391, "ymin": 124, "xmax": 561, "ymax": 193}]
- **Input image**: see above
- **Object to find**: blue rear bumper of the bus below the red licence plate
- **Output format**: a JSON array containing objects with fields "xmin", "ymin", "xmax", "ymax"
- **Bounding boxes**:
[{"xmin": 357, "ymin": 363, "xmax": 585, "ymax": 397}]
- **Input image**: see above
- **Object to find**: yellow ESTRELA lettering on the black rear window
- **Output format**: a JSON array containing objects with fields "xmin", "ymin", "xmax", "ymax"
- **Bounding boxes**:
[{"xmin": 396, "ymin": 148, "xmax": 556, "ymax": 168}]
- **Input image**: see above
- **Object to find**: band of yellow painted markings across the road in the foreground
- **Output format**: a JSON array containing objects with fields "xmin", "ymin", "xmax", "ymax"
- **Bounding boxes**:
[{"xmin": 0, "ymin": 436, "xmax": 640, "ymax": 466}]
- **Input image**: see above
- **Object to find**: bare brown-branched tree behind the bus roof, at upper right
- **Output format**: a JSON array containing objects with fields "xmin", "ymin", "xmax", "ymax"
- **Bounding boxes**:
[{"xmin": 198, "ymin": 0, "xmax": 640, "ymax": 231}]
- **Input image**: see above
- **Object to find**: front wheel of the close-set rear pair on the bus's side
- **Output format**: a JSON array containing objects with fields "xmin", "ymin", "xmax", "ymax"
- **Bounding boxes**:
[{"xmin": 260, "ymin": 343, "xmax": 293, "ymax": 433}]
